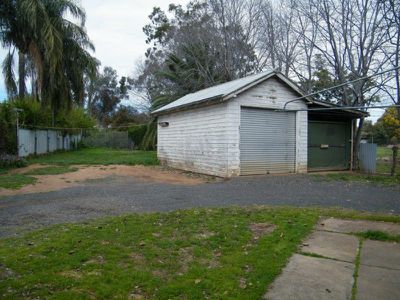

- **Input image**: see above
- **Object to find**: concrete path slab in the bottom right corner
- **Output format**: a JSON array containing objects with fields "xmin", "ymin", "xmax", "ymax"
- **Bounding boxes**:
[{"xmin": 356, "ymin": 265, "xmax": 400, "ymax": 300}]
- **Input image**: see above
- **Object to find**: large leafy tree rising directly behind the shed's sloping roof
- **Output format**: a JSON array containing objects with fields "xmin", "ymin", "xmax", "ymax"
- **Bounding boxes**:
[{"xmin": 133, "ymin": 1, "xmax": 256, "ymax": 109}]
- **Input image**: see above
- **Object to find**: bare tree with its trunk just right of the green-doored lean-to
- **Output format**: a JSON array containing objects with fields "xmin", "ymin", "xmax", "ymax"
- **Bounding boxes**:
[{"xmin": 296, "ymin": 0, "xmax": 387, "ymax": 165}]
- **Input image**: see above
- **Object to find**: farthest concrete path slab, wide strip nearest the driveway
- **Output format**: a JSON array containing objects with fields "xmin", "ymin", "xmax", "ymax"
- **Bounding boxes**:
[{"xmin": 317, "ymin": 218, "xmax": 400, "ymax": 235}]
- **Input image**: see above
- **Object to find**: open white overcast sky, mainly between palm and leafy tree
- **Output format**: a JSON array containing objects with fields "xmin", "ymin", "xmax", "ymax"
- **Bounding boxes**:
[{"xmin": 0, "ymin": 0, "xmax": 382, "ymax": 120}]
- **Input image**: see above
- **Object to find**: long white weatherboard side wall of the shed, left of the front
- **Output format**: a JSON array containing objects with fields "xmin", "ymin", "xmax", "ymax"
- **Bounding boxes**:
[{"xmin": 157, "ymin": 103, "xmax": 230, "ymax": 177}]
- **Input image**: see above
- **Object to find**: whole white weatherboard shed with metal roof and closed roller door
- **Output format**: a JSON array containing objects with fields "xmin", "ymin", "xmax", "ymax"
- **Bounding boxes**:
[{"xmin": 153, "ymin": 71, "xmax": 366, "ymax": 177}]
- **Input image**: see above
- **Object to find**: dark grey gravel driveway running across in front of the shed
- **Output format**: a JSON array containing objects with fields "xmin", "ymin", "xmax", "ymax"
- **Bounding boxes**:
[{"xmin": 0, "ymin": 175, "xmax": 400, "ymax": 237}]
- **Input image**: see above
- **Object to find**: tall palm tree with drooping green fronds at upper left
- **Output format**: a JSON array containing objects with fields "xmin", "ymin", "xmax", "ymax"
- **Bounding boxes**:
[{"xmin": 0, "ymin": 0, "xmax": 98, "ymax": 110}]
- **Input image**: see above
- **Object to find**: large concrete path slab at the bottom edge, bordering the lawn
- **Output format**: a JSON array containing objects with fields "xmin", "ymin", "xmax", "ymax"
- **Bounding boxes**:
[{"xmin": 264, "ymin": 254, "xmax": 354, "ymax": 300}]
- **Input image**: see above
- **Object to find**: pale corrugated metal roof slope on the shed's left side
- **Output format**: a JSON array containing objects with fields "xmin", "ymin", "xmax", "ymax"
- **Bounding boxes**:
[{"xmin": 153, "ymin": 71, "xmax": 276, "ymax": 114}]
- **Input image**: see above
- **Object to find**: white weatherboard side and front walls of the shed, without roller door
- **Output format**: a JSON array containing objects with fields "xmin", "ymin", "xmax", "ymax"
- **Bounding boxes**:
[{"xmin": 157, "ymin": 78, "xmax": 308, "ymax": 177}]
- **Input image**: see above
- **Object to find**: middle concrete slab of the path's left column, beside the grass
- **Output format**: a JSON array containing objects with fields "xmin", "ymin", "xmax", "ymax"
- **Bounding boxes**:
[{"xmin": 301, "ymin": 231, "xmax": 359, "ymax": 262}]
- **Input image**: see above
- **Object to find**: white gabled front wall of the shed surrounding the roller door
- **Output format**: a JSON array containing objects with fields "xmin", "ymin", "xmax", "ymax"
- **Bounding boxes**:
[{"xmin": 228, "ymin": 78, "xmax": 308, "ymax": 176}]
